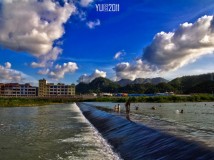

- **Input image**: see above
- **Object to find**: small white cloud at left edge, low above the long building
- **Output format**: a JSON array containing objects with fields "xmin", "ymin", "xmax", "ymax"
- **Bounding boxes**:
[{"xmin": 0, "ymin": 62, "xmax": 25, "ymax": 82}]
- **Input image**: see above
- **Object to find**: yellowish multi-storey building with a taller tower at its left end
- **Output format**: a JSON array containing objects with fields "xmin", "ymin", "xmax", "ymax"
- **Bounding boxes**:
[{"xmin": 38, "ymin": 79, "xmax": 75, "ymax": 97}]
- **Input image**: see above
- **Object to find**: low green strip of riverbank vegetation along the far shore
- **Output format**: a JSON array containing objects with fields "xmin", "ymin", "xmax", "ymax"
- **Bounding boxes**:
[{"xmin": 0, "ymin": 94, "xmax": 214, "ymax": 107}]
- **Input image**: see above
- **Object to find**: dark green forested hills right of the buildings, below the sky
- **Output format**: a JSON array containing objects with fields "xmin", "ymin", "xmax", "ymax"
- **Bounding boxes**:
[{"xmin": 76, "ymin": 74, "xmax": 214, "ymax": 94}]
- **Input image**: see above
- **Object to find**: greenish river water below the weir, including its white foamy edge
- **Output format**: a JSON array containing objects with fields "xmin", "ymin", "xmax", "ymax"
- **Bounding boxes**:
[{"xmin": 0, "ymin": 103, "xmax": 120, "ymax": 160}]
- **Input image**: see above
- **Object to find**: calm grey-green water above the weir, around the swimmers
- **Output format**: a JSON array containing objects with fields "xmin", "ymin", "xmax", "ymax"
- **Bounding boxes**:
[{"xmin": 85, "ymin": 102, "xmax": 214, "ymax": 148}]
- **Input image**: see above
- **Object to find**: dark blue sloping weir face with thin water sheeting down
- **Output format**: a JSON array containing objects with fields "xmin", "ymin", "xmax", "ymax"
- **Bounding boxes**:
[{"xmin": 77, "ymin": 103, "xmax": 214, "ymax": 160}]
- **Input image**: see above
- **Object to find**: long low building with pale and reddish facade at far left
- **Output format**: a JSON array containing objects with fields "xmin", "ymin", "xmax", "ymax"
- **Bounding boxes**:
[{"xmin": 0, "ymin": 83, "xmax": 38, "ymax": 97}]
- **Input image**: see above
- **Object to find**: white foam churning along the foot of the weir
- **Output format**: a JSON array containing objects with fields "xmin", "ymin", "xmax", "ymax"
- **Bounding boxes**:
[{"xmin": 58, "ymin": 103, "xmax": 121, "ymax": 160}]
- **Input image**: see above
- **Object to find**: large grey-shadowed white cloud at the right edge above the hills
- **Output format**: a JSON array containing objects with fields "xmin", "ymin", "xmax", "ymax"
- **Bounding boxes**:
[{"xmin": 142, "ymin": 16, "xmax": 214, "ymax": 71}]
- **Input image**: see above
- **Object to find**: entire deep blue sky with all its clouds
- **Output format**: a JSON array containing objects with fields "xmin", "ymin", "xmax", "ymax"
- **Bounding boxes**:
[{"xmin": 0, "ymin": 0, "xmax": 214, "ymax": 83}]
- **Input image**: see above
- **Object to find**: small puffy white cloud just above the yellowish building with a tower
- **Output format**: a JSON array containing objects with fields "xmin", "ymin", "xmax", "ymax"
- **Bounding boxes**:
[{"xmin": 38, "ymin": 62, "xmax": 78, "ymax": 79}]
